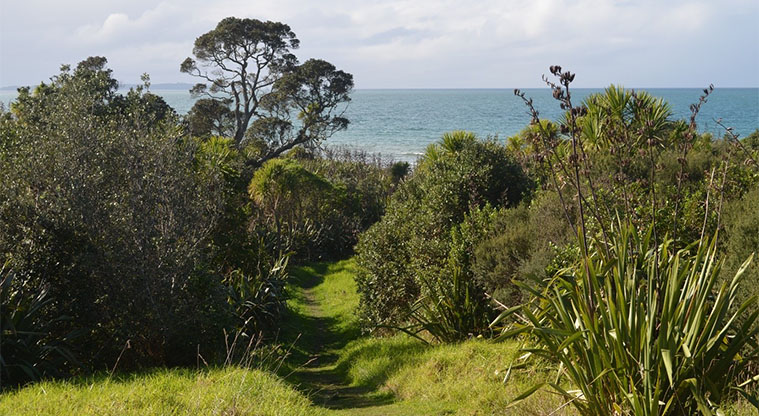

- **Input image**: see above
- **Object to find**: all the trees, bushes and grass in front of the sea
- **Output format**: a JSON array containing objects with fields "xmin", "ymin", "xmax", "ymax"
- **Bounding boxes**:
[{"xmin": 0, "ymin": 14, "xmax": 759, "ymax": 415}]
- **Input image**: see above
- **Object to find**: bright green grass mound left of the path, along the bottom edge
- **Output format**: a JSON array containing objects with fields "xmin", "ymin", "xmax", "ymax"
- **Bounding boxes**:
[{"xmin": 0, "ymin": 368, "xmax": 323, "ymax": 416}]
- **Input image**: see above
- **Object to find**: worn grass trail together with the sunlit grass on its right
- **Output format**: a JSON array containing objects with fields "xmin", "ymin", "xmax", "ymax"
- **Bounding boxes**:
[{"xmin": 283, "ymin": 259, "xmax": 567, "ymax": 415}]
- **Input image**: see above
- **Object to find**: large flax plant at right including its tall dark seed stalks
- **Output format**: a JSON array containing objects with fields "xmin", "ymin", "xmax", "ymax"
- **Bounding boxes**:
[{"xmin": 498, "ymin": 66, "xmax": 759, "ymax": 415}]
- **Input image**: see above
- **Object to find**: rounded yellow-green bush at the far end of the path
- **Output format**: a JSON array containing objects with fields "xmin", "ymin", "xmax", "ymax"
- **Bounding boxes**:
[{"xmin": 249, "ymin": 148, "xmax": 396, "ymax": 261}]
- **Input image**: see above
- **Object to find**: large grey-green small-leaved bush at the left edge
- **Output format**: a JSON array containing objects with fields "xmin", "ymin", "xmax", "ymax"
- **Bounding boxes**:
[{"xmin": 0, "ymin": 58, "xmax": 226, "ymax": 365}]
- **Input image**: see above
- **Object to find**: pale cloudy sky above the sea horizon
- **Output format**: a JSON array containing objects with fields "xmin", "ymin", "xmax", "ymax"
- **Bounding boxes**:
[{"xmin": 0, "ymin": 0, "xmax": 759, "ymax": 88}]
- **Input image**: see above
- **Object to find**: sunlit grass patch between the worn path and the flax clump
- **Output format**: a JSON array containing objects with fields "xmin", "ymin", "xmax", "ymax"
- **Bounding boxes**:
[{"xmin": 330, "ymin": 335, "xmax": 574, "ymax": 415}]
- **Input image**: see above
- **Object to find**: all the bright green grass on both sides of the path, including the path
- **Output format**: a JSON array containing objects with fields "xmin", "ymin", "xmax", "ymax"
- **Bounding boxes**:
[{"xmin": 0, "ymin": 260, "xmax": 753, "ymax": 415}]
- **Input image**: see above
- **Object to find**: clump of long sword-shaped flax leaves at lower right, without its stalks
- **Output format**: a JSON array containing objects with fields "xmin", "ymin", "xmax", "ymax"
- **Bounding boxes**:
[{"xmin": 502, "ymin": 224, "xmax": 759, "ymax": 415}]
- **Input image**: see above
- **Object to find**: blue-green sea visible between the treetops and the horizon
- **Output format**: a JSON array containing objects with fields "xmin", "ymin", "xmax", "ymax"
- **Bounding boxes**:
[{"xmin": 0, "ymin": 88, "xmax": 759, "ymax": 161}]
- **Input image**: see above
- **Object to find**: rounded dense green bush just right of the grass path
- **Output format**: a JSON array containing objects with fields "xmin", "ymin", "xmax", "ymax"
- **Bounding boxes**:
[{"xmin": 357, "ymin": 132, "xmax": 530, "ymax": 337}]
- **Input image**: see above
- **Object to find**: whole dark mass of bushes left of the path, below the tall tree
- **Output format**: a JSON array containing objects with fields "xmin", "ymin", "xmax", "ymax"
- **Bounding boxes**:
[{"xmin": 0, "ymin": 58, "xmax": 285, "ymax": 385}]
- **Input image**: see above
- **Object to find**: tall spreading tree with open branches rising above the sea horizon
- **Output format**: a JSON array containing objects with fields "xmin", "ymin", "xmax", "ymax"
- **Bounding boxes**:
[{"xmin": 180, "ymin": 17, "xmax": 353, "ymax": 166}]
